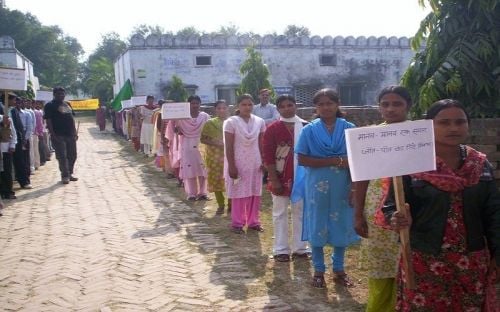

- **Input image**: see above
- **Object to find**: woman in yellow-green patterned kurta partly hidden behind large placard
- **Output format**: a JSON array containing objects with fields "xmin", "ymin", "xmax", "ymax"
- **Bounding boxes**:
[{"xmin": 354, "ymin": 86, "xmax": 412, "ymax": 312}]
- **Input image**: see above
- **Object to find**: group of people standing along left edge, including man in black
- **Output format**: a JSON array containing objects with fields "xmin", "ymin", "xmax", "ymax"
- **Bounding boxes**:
[{"xmin": 0, "ymin": 87, "xmax": 78, "ymax": 214}]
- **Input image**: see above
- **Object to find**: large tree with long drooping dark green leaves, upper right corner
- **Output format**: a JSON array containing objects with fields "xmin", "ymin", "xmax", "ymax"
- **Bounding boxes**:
[{"xmin": 402, "ymin": 0, "xmax": 500, "ymax": 117}]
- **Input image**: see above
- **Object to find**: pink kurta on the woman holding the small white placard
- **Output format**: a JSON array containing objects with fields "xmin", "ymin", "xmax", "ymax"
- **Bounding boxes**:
[{"xmin": 167, "ymin": 112, "xmax": 210, "ymax": 179}]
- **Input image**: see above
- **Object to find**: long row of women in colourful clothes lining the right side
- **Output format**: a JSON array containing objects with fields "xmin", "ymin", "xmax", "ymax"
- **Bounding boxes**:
[{"xmin": 103, "ymin": 86, "xmax": 500, "ymax": 311}]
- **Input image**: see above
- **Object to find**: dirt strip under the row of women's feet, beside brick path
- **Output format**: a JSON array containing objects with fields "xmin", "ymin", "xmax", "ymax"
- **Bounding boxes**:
[{"xmin": 108, "ymin": 127, "xmax": 367, "ymax": 311}]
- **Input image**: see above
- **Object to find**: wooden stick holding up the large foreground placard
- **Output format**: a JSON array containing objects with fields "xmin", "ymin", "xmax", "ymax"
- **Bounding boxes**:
[{"xmin": 392, "ymin": 176, "xmax": 415, "ymax": 289}]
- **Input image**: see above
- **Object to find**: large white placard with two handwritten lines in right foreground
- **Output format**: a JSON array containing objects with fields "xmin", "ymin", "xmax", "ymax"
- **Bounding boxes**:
[{"xmin": 345, "ymin": 120, "xmax": 436, "ymax": 181}]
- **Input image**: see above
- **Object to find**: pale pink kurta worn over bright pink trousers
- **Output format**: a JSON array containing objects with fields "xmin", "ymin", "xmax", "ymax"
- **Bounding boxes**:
[{"xmin": 223, "ymin": 115, "xmax": 266, "ymax": 198}]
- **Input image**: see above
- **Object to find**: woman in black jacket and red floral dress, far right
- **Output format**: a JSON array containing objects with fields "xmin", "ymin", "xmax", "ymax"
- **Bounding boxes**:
[{"xmin": 386, "ymin": 99, "xmax": 500, "ymax": 311}]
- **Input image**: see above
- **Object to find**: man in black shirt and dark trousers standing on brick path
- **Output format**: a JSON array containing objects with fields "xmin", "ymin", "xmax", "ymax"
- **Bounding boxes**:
[{"xmin": 43, "ymin": 87, "xmax": 78, "ymax": 184}]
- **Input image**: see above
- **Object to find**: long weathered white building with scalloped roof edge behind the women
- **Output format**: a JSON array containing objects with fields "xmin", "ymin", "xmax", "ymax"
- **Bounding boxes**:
[{"xmin": 114, "ymin": 34, "xmax": 414, "ymax": 105}]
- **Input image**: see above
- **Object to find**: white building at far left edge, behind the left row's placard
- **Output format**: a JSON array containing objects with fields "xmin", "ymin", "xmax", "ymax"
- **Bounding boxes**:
[{"xmin": 0, "ymin": 36, "xmax": 40, "ymax": 92}]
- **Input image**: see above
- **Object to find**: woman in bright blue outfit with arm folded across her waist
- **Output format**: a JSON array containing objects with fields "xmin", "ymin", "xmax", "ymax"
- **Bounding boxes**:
[{"xmin": 294, "ymin": 89, "xmax": 358, "ymax": 288}]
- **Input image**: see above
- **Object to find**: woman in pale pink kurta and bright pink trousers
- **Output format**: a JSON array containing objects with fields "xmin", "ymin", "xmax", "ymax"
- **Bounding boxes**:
[{"xmin": 223, "ymin": 94, "xmax": 266, "ymax": 234}]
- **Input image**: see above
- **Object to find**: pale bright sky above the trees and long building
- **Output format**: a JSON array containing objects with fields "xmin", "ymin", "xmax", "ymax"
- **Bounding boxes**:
[{"xmin": 5, "ymin": 0, "xmax": 429, "ymax": 55}]
